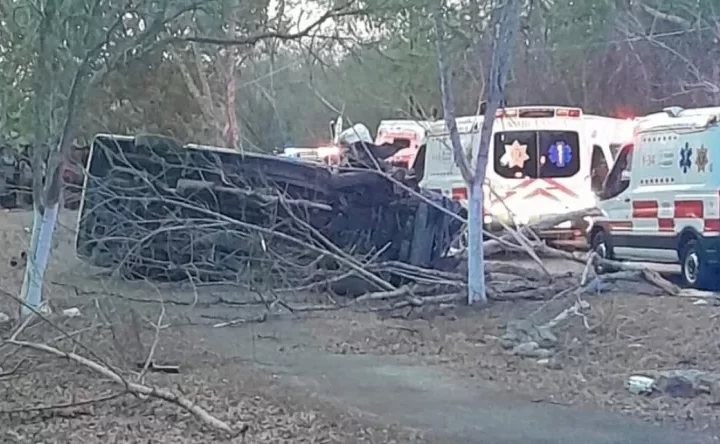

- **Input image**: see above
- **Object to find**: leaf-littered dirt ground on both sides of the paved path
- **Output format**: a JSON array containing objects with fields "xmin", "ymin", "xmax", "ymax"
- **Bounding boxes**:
[{"xmin": 0, "ymin": 212, "xmax": 720, "ymax": 443}]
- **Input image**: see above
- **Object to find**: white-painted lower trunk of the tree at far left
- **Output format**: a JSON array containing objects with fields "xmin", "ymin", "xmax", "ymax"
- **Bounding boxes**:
[{"xmin": 20, "ymin": 202, "xmax": 60, "ymax": 317}]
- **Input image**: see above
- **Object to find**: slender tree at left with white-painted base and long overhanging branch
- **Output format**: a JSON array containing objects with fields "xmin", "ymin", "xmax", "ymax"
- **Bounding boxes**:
[{"xmin": 0, "ymin": 0, "xmax": 358, "ymax": 314}]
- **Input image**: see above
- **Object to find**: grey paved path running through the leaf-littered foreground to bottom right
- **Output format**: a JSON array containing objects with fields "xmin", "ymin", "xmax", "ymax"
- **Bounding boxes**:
[{"xmin": 186, "ymin": 321, "xmax": 713, "ymax": 444}]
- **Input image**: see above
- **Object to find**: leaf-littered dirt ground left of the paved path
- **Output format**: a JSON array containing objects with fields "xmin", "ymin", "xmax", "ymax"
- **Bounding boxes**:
[{"xmin": 0, "ymin": 211, "xmax": 424, "ymax": 443}]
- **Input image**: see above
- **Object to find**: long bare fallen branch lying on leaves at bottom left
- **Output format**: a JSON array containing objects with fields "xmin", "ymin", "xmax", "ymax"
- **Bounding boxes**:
[{"xmin": 6, "ymin": 340, "xmax": 234, "ymax": 435}]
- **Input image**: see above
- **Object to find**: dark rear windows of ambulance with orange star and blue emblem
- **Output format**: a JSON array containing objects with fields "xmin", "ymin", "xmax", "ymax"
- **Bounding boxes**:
[{"xmin": 493, "ymin": 131, "xmax": 580, "ymax": 179}]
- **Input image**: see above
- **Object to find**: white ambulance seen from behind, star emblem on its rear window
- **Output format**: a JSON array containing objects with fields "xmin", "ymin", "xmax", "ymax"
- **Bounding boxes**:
[{"xmin": 420, "ymin": 106, "xmax": 634, "ymax": 244}]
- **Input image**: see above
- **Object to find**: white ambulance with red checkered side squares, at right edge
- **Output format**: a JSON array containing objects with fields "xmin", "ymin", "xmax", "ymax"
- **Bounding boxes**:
[{"xmin": 591, "ymin": 107, "xmax": 720, "ymax": 289}]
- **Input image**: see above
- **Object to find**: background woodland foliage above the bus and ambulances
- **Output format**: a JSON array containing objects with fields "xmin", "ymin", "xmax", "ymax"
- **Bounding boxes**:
[{"xmin": 0, "ymin": 0, "xmax": 720, "ymax": 150}]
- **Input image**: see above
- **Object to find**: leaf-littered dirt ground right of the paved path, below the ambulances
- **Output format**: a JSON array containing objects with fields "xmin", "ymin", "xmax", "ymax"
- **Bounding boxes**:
[{"xmin": 310, "ymin": 263, "xmax": 720, "ymax": 430}]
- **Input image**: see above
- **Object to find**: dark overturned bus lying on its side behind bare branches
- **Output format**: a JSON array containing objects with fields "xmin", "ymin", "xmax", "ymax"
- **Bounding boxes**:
[{"xmin": 76, "ymin": 134, "xmax": 463, "ymax": 280}]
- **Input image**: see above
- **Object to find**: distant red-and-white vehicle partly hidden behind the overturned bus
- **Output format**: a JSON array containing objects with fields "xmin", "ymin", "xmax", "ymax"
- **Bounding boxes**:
[{"xmin": 375, "ymin": 120, "xmax": 430, "ymax": 168}]
